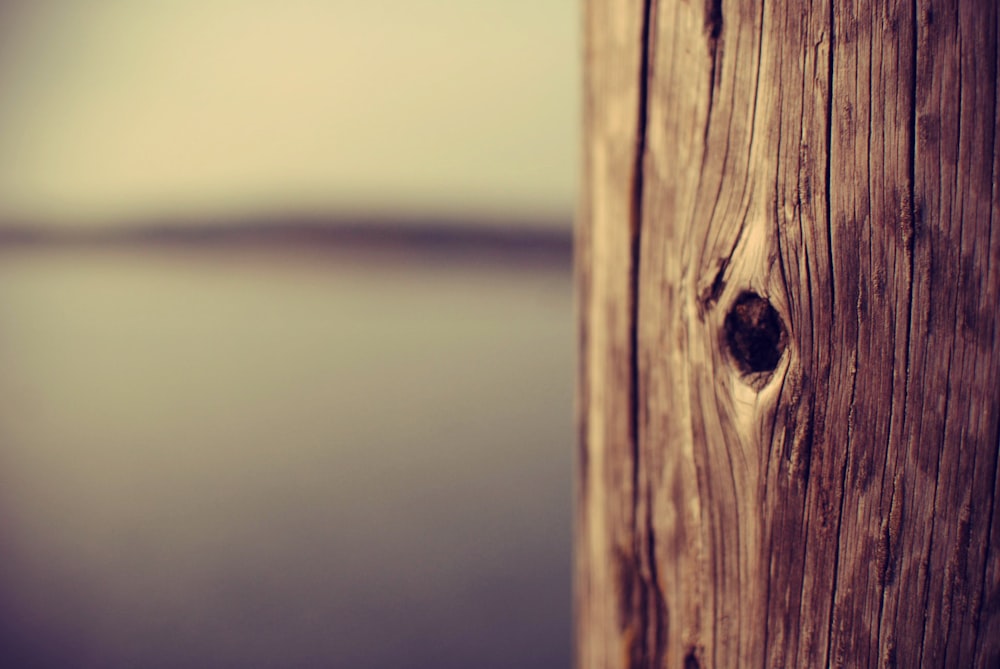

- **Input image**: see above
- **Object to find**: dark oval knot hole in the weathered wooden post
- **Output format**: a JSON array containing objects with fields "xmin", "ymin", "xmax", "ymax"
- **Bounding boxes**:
[{"xmin": 723, "ymin": 291, "xmax": 788, "ymax": 374}]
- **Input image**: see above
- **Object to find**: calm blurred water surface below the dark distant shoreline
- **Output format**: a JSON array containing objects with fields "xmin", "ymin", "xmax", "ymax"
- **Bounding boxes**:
[{"xmin": 0, "ymin": 248, "xmax": 575, "ymax": 669}]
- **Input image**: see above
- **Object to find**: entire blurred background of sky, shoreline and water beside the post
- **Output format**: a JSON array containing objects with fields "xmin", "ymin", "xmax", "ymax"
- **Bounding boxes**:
[{"xmin": 0, "ymin": 0, "xmax": 581, "ymax": 668}]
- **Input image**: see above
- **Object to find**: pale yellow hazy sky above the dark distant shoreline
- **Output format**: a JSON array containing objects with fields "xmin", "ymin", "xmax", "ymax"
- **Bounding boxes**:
[{"xmin": 0, "ymin": 0, "xmax": 580, "ymax": 225}]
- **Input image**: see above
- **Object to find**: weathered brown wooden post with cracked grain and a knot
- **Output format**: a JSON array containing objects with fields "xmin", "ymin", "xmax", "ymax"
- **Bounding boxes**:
[{"xmin": 575, "ymin": 0, "xmax": 1000, "ymax": 669}]
